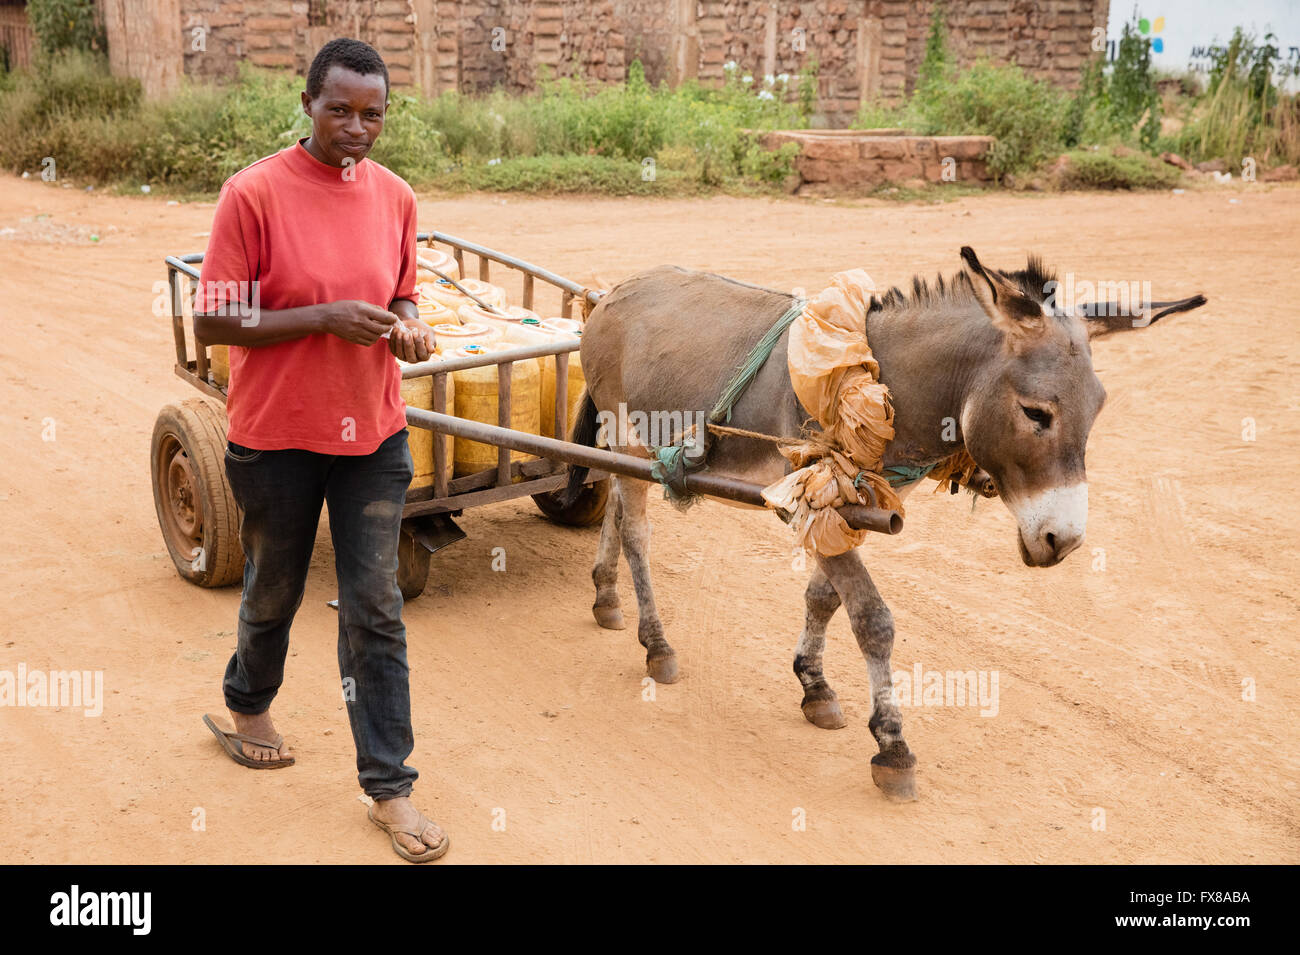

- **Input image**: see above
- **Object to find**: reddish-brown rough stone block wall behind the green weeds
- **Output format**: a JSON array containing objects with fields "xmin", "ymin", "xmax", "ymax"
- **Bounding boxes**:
[{"xmin": 170, "ymin": 0, "xmax": 1109, "ymax": 126}]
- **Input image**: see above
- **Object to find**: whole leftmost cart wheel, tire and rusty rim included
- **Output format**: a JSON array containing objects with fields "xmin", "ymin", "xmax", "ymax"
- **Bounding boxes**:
[{"xmin": 151, "ymin": 398, "xmax": 244, "ymax": 587}]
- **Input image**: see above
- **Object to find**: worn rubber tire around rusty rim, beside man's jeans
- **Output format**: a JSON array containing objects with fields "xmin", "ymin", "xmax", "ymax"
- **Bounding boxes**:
[{"xmin": 150, "ymin": 398, "xmax": 244, "ymax": 587}]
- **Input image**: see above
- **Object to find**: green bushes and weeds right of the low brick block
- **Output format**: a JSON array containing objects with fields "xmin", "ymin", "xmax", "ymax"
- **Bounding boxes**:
[{"xmin": 854, "ymin": 4, "xmax": 1300, "ymax": 188}]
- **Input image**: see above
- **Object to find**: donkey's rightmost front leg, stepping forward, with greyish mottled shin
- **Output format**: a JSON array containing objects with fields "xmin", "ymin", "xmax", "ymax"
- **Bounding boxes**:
[{"xmin": 818, "ymin": 551, "xmax": 917, "ymax": 799}]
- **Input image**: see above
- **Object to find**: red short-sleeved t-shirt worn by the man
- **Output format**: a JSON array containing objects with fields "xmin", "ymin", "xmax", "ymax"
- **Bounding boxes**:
[{"xmin": 195, "ymin": 140, "xmax": 417, "ymax": 455}]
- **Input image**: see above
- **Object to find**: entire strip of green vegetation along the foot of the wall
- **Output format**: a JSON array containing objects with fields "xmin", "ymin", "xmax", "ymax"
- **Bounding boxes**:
[{"xmin": 0, "ymin": 12, "xmax": 1300, "ymax": 195}]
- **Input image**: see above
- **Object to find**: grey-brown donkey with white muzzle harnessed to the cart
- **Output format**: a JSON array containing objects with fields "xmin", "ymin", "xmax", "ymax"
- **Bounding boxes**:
[{"xmin": 567, "ymin": 247, "xmax": 1205, "ymax": 799}]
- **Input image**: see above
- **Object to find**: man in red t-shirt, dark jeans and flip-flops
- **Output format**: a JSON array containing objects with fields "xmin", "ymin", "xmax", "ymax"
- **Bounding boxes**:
[{"xmin": 195, "ymin": 39, "xmax": 449, "ymax": 863}]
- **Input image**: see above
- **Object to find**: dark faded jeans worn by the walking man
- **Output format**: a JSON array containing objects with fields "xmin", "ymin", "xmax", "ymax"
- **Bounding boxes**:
[{"xmin": 224, "ymin": 429, "xmax": 419, "ymax": 799}]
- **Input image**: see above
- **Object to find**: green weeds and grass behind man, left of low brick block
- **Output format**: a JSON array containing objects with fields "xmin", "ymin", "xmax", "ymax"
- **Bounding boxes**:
[{"xmin": 0, "ymin": 51, "xmax": 815, "ymax": 195}]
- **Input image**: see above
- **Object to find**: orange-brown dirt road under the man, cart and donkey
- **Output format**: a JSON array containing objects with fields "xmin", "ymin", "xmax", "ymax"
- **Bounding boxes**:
[{"xmin": 0, "ymin": 178, "xmax": 1300, "ymax": 864}]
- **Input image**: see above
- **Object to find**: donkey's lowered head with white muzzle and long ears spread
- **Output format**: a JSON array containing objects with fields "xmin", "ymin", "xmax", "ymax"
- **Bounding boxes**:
[{"xmin": 961, "ymin": 247, "xmax": 1205, "ymax": 567}]
